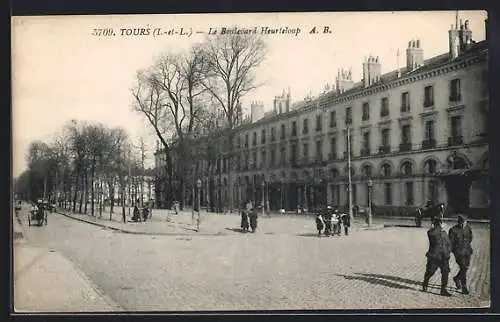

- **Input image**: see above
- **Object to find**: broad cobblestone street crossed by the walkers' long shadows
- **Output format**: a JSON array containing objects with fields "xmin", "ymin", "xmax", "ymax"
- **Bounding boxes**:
[{"xmin": 14, "ymin": 206, "xmax": 490, "ymax": 311}]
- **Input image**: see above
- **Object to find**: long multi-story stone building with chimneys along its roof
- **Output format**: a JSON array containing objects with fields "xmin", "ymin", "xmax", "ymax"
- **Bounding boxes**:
[{"xmin": 157, "ymin": 21, "xmax": 489, "ymax": 219}]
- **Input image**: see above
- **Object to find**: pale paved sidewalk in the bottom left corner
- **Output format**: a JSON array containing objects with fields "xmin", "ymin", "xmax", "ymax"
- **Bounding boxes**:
[{"xmin": 12, "ymin": 205, "xmax": 123, "ymax": 313}]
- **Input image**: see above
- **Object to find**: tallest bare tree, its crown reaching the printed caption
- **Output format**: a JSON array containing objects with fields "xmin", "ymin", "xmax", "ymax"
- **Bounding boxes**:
[{"xmin": 202, "ymin": 34, "xmax": 267, "ymax": 208}]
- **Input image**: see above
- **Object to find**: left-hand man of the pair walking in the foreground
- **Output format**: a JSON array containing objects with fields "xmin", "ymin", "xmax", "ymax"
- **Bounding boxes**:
[{"xmin": 422, "ymin": 218, "xmax": 451, "ymax": 296}]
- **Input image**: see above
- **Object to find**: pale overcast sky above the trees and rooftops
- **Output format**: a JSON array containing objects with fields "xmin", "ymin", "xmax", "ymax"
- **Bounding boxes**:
[{"xmin": 12, "ymin": 11, "xmax": 487, "ymax": 176}]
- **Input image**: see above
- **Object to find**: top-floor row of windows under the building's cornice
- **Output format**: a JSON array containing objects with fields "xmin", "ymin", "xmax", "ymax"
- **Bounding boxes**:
[{"xmin": 237, "ymin": 79, "xmax": 461, "ymax": 147}]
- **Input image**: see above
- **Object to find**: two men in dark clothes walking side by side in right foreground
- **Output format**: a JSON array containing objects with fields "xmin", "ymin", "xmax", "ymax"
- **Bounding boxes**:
[{"xmin": 422, "ymin": 215, "xmax": 472, "ymax": 296}]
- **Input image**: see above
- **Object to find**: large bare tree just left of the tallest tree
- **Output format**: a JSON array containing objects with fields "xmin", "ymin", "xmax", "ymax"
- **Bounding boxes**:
[{"xmin": 134, "ymin": 47, "xmax": 205, "ymax": 207}]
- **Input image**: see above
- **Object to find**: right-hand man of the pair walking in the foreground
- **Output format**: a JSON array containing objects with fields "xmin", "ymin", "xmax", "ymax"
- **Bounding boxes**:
[{"xmin": 448, "ymin": 215, "xmax": 472, "ymax": 294}]
